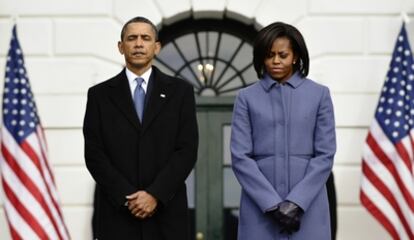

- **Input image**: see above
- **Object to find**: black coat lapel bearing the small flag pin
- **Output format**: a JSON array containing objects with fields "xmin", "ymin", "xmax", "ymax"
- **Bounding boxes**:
[{"xmin": 142, "ymin": 67, "xmax": 174, "ymax": 132}]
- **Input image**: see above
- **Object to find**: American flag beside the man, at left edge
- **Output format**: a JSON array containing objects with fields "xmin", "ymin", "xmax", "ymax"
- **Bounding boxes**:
[{"xmin": 0, "ymin": 26, "xmax": 69, "ymax": 239}]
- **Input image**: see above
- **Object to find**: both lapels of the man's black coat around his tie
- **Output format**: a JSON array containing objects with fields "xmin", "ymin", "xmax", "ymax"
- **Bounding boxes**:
[{"xmin": 109, "ymin": 66, "xmax": 175, "ymax": 132}]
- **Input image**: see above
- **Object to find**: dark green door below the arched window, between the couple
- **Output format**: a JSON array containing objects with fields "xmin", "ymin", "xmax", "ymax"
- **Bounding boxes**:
[{"xmin": 195, "ymin": 97, "xmax": 240, "ymax": 240}]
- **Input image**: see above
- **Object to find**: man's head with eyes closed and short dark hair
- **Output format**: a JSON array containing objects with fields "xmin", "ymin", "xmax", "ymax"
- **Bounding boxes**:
[{"xmin": 118, "ymin": 22, "xmax": 161, "ymax": 75}]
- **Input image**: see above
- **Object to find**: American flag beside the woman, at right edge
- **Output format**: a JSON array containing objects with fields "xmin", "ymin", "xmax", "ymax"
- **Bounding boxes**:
[{"xmin": 360, "ymin": 23, "xmax": 414, "ymax": 239}]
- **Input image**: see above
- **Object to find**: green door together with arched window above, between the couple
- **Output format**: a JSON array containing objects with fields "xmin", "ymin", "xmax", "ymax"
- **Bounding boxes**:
[{"xmin": 154, "ymin": 17, "xmax": 257, "ymax": 240}]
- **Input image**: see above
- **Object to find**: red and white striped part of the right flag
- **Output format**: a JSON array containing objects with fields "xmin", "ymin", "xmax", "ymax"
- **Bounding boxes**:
[{"xmin": 360, "ymin": 119, "xmax": 414, "ymax": 239}]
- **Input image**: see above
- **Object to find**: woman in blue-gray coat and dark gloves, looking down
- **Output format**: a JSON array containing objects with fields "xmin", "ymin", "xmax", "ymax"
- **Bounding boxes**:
[{"xmin": 231, "ymin": 22, "xmax": 336, "ymax": 240}]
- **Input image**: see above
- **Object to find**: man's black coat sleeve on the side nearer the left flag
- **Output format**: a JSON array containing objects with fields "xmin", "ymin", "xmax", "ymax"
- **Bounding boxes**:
[{"xmin": 83, "ymin": 88, "xmax": 136, "ymax": 207}]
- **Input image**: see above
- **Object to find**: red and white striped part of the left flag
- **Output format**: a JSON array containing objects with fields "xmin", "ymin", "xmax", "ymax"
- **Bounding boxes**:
[{"xmin": 0, "ymin": 126, "xmax": 70, "ymax": 239}]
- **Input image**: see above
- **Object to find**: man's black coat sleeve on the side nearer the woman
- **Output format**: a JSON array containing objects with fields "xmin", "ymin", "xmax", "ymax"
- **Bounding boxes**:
[{"xmin": 146, "ymin": 84, "xmax": 198, "ymax": 206}]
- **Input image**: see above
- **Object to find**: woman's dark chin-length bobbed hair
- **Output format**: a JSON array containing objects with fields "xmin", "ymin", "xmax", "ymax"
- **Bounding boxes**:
[{"xmin": 253, "ymin": 22, "xmax": 309, "ymax": 78}]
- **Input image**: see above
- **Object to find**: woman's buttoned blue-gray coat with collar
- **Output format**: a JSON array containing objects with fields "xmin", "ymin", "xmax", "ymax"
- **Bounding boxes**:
[{"xmin": 231, "ymin": 73, "xmax": 336, "ymax": 240}]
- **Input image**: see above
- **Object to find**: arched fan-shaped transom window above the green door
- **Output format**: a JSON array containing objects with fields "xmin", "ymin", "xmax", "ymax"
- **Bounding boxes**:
[{"xmin": 154, "ymin": 19, "xmax": 257, "ymax": 96}]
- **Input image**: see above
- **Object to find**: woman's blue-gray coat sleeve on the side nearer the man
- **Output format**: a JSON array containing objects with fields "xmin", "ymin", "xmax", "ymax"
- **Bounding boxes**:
[{"xmin": 230, "ymin": 91, "xmax": 282, "ymax": 212}]
